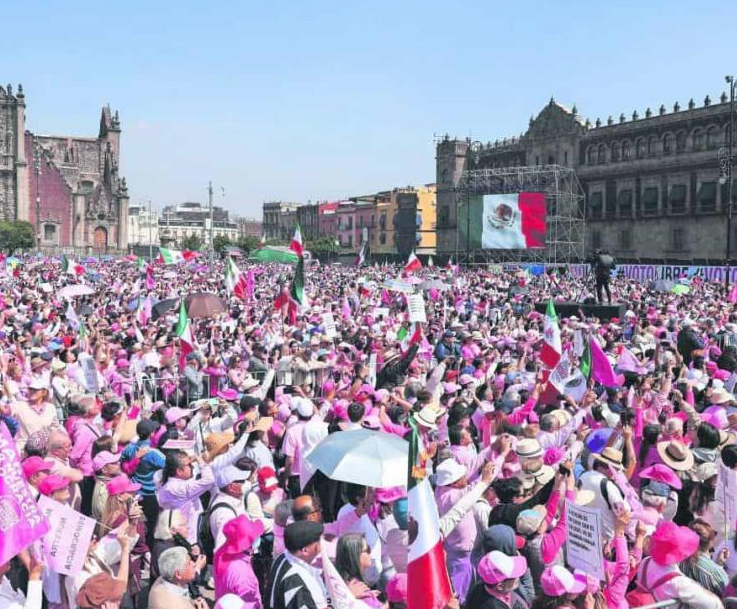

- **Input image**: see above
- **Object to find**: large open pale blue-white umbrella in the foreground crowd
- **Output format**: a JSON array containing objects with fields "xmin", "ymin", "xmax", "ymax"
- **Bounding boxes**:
[{"xmin": 306, "ymin": 429, "xmax": 409, "ymax": 488}]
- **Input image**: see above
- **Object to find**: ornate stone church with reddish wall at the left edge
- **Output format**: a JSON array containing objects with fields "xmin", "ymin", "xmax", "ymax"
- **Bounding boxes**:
[{"xmin": 0, "ymin": 85, "xmax": 129, "ymax": 253}]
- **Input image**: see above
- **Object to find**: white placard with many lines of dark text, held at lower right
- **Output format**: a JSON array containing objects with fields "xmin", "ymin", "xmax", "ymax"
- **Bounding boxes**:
[{"xmin": 566, "ymin": 500, "xmax": 606, "ymax": 580}]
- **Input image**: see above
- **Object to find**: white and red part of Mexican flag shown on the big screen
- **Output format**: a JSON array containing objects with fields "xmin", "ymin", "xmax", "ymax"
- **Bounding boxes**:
[{"xmin": 478, "ymin": 192, "xmax": 547, "ymax": 249}]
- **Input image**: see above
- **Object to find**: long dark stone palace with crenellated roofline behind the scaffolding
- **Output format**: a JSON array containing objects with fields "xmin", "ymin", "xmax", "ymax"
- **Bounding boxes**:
[{"xmin": 436, "ymin": 94, "xmax": 737, "ymax": 264}]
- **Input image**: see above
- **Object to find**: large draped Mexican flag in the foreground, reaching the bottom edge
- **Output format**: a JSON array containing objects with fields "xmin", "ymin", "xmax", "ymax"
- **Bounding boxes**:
[{"xmin": 407, "ymin": 416, "xmax": 451, "ymax": 609}]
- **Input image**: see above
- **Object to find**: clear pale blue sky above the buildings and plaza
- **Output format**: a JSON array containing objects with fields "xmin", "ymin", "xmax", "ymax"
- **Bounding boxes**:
[{"xmin": 0, "ymin": 0, "xmax": 737, "ymax": 216}]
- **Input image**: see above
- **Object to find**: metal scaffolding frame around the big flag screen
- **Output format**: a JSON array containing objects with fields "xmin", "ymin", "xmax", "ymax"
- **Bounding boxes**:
[{"xmin": 455, "ymin": 165, "xmax": 586, "ymax": 264}]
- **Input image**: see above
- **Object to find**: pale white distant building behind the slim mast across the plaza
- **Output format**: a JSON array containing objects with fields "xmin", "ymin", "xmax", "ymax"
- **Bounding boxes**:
[{"xmin": 159, "ymin": 201, "xmax": 239, "ymax": 247}]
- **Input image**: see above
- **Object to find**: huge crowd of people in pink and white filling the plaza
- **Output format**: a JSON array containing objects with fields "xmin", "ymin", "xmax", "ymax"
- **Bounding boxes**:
[{"xmin": 0, "ymin": 249, "xmax": 737, "ymax": 609}]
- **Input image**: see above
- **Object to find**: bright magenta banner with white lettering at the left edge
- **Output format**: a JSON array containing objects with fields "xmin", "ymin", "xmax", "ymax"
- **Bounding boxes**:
[{"xmin": 0, "ymin": 422, "xmax": 49, "ymax": 565}]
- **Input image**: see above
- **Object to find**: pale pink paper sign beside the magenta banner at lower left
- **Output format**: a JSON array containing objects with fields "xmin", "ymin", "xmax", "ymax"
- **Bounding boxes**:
[{"xmin": 38, "ymin": 495, "xmax": 95, "ymax": 575}]
